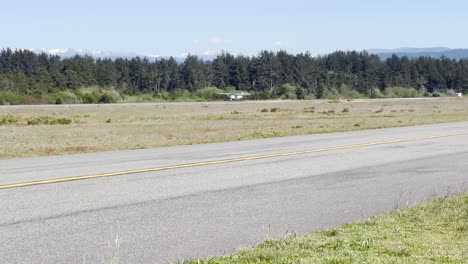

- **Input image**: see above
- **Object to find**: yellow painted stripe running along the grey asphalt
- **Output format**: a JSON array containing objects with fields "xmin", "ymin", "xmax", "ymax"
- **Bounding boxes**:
[{"xmin": 0, "ymin": 132, "xmax": 468, "ymax": 189}]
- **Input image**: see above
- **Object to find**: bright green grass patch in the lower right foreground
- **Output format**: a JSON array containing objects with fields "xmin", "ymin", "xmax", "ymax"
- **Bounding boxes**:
[{"xmin": 187, "ymin": 195, "xmax": 468, "ymax": 263}]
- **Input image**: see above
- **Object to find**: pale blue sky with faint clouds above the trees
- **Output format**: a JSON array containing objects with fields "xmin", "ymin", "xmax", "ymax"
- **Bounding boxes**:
[{"xmin": 0, "ymin": 0, "xmax": 468, "ymax": 56}]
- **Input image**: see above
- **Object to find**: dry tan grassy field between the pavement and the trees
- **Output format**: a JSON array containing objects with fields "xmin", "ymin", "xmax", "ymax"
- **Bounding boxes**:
[{"xmin": 0, "ymin": 98, "xmax": 468, "ymax": 159}]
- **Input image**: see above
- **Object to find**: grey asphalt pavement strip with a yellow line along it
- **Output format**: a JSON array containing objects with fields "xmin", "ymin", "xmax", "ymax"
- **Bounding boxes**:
[{"xmin": 0, "ymin": 122, "xmax": 468, "ymax": 263}]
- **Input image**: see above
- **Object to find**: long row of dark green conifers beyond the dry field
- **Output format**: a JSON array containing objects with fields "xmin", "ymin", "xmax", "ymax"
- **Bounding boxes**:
[{"xmin": 0, "ymin": 49, "xmax": 468, "ymax": 103}]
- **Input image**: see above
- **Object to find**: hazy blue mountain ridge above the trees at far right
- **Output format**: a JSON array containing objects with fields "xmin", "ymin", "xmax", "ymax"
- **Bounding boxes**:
[{"xmin": 367, "ymin": 47, "xmax": 468, "ymax": 60}]
